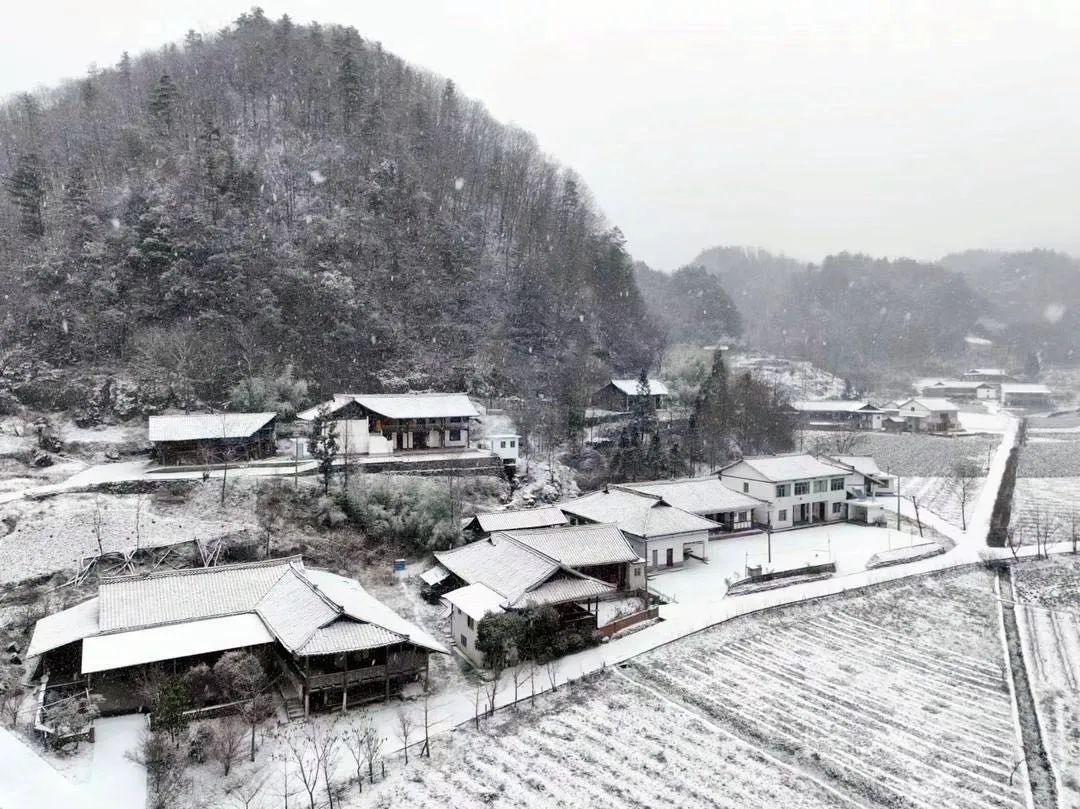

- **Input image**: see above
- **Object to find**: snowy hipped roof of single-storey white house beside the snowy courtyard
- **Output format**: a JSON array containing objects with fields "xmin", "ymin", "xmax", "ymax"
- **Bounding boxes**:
[{"xmin": 559, "ymin": 486, "xmax": 717, "ymax": 539}]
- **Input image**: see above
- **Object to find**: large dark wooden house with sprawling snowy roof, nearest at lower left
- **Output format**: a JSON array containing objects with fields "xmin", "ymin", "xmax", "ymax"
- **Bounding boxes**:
[{"xmin": 27, "ymin": 556, "xmax": 447, "ymax": 715}]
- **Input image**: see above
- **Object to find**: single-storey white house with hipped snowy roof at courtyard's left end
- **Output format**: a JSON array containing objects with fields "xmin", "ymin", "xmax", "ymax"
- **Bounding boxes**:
[{"xmin": 558, "ymin": 486, "xmax": 724, "ymax": 570}]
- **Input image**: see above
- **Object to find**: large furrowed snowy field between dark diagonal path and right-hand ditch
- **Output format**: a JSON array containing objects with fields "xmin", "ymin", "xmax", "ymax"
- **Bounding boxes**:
[{"xmin": 629, "ymin": 571, "xmax": 1025, "ymax": 809}]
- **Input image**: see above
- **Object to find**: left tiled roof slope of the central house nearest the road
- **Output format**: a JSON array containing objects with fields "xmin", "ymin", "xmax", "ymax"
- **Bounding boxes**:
[{"xmin": 435, "ymin": 534, "xmax": 558, "ymax": 601}]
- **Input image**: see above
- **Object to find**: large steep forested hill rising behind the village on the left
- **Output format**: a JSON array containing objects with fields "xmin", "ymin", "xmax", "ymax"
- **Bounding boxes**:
[{"xmin": 0, "ymin": 9, "xmax": 660, "ymax": 412}]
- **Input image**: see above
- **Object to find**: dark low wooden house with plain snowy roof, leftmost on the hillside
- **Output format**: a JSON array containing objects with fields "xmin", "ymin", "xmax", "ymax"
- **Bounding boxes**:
[{"xmin": 148, "ymin": 413, "xmax": 278, "ymax": 466}]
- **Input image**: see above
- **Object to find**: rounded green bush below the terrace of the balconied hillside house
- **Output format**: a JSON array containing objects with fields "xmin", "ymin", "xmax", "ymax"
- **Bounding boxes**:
[{"xmin": 339, "ymin": 475, "xmax": 461, "ymax": 551}]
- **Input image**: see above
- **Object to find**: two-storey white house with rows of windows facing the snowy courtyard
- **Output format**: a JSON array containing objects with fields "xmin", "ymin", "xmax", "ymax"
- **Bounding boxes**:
[{"xmin": 720, "ymin": 454, "xmax": 856, "ymax": 529}]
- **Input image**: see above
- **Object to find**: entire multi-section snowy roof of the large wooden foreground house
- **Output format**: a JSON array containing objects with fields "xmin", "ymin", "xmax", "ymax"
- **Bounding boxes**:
[{"xmin": 30, "ymin": 556, "xmax": 446, "ymax": 672}]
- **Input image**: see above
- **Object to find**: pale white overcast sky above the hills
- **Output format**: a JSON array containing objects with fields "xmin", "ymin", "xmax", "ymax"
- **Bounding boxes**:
[{"xmin": 0, "ymin": 0, "xmax": 1080, "ymax": 269}]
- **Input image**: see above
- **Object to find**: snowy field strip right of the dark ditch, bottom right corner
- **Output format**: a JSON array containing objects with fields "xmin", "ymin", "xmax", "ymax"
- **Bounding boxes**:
[{"xmin": 1013, "ymin": 557, "xmax": 1080, "ymax": 809}]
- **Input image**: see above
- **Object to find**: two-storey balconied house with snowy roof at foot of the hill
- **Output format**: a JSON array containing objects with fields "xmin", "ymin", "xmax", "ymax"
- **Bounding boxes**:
[{"xmin": 297, "ymin": 393, "xmax": 480, "ymax": 456}]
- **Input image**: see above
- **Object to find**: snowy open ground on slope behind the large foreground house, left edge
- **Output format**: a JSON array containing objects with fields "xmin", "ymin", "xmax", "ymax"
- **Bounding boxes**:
[{"xmin": 0, "ymin": 484, "xmax": 255, "ymax": 582}]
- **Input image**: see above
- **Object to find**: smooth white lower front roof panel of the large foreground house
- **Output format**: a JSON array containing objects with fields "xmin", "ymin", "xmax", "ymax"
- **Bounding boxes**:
[{"xmin": 82, "ymin": 612, "xmax": 273, "ymax": 674}]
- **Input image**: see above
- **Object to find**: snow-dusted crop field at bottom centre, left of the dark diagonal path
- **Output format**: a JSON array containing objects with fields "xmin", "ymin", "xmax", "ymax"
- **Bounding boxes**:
[{"xmin": 367, "ymin": 673, "xmax": 852, "ymax": 809}]
